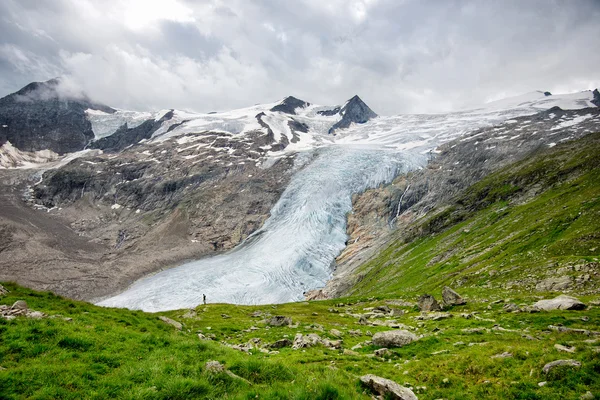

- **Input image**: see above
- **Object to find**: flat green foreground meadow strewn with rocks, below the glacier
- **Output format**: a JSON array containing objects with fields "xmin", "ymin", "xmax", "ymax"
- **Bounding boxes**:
[{"xmin": 0, "ymin": 284, "xmax": 600, "ymax": 399}]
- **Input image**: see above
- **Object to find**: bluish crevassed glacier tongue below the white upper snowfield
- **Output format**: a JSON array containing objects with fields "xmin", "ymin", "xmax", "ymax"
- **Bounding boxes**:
[{"xmin": 99, "ymin": 145, "xmax": 423, "ymax": 311}]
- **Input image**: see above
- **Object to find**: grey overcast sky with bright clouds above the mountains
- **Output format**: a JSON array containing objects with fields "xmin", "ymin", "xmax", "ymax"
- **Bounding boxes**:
[{"xmin": 0, "ymin": 0, "xmax": 600, "ymax": 115}]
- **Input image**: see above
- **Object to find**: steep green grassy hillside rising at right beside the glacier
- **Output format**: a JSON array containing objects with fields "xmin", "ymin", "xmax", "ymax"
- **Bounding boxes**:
[{"xmin": 348, "ymin": 134, "xmax": 600, "ymax": 296}]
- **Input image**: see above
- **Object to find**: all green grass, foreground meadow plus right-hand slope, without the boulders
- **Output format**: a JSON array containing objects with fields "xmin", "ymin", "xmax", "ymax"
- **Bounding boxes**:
[{"xmin": 0, "ymin": 135, "xmax": 600, "ymax": 399}]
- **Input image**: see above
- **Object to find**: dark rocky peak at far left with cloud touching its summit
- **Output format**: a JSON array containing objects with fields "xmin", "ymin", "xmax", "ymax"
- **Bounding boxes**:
[{"xmin": 0, "ymin": 79, "xmax": 115, "ymax": 154}]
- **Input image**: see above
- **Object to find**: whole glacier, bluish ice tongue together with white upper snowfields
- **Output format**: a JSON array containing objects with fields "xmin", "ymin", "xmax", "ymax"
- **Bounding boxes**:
[{"xmin": 97, "ymin": 92, "xmax": 590, "ymax": 312}]
